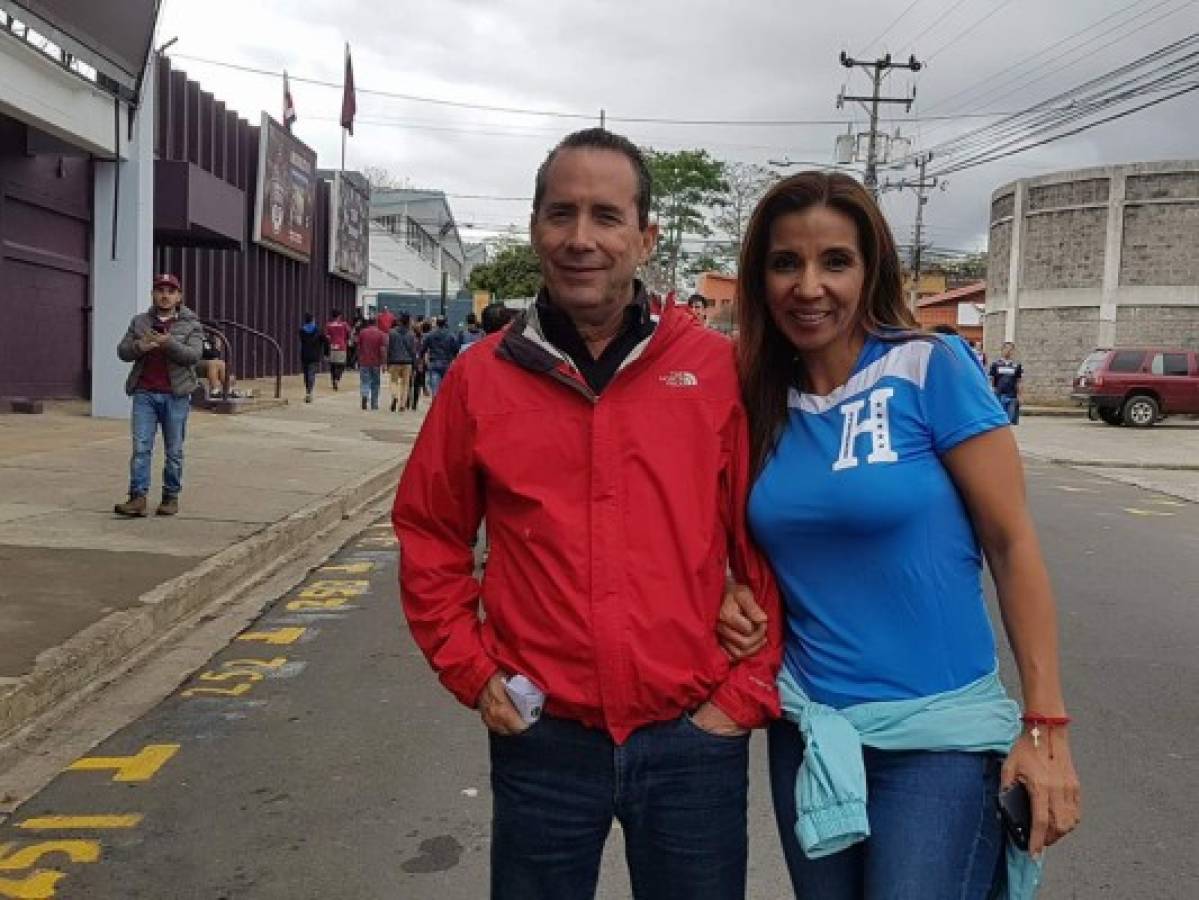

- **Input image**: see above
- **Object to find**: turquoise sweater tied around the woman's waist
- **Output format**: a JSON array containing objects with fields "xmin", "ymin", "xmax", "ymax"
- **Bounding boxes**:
[{"xmin": 778, "ymin": 666, "xmax": 1042, "ymax": 900}]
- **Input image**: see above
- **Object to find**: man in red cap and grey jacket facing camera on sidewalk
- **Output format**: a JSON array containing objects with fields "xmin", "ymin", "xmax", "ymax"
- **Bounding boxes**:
[{"xmin": 113, "ymin": 274, "xmax": 204, "ymax": 517}]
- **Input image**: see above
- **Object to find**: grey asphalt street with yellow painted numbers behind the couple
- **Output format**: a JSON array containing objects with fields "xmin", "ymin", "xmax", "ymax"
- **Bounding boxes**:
[{"xmin": 0, "ymin": 464, "xmax": 1199, "ymax": 900}]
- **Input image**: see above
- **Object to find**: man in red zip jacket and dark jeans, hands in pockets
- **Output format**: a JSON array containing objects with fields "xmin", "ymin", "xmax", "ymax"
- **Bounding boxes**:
[{"xmin": 392, "ymin": 128, "xmax": 781, "ymax": 900}]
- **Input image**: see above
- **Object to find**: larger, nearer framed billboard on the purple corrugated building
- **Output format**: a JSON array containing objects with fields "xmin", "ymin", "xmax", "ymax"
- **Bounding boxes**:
[{"xmin": 254, "ymin": 113, "xmax": 317, "ymax": 262}]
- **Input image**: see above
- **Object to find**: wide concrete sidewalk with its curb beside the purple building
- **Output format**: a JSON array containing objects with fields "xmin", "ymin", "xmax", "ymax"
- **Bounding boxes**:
[{"xmin": 0, "ymin": 372, "xmax": 427, "ymax": 736}]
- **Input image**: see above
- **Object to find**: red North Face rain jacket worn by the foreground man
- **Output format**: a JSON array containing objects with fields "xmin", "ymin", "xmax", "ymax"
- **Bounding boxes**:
[{"xmin": 392, "ymin": 299, "xmax": 782, "ymax": 743}]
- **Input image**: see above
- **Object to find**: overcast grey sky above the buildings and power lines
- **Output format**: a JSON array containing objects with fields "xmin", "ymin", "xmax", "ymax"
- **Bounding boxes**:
[{"xmin": 158, "ymin": 0, "xmax": 1199, "ymax": 258}]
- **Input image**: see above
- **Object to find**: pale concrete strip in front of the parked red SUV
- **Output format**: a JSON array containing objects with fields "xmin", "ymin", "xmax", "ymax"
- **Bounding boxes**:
[{"xmin": 1016, "ymin": 416, "xmax": 1199, "ymax": 503}]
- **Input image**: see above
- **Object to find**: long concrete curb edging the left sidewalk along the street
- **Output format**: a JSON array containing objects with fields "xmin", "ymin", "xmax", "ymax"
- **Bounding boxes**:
[{"xmin": 0, "ymin": 448, "xmax": 408, "ymax": 738}]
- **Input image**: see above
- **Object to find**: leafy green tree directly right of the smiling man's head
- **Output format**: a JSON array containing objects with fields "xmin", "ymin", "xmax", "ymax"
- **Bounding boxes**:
[{"xmin": 645, "ymin": 149, "xmax": 728, "ymax": 288}]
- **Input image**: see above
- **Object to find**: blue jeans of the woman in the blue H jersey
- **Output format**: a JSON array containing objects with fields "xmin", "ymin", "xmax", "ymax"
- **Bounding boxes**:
[{"xmin": 770, "ymin": 720, "xmax": 1004, "ymax": 900}]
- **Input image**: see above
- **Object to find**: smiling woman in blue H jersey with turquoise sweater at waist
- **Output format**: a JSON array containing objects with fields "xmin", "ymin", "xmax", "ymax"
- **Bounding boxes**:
[{"xmin": 721, "ymin": 173, "xmax": 1079, "ymax": 900}]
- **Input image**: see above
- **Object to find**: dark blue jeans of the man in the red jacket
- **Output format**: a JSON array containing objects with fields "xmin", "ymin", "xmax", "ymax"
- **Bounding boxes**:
[{"xmin": 490, "ymin": 717, "xmax": 749, "ymax": 900}]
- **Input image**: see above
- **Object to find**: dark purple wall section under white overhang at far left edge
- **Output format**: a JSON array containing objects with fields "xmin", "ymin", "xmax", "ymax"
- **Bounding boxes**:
[{"xmin": 0, "ymin": 116, "xmax": 92, "ymax": 398}]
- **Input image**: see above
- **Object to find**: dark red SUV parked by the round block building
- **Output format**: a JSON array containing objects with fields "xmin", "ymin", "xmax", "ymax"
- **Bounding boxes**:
[{"xmin": 1070, "ymin": 346, "xmax": 1199, "ymax": 428}]
